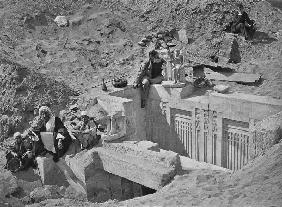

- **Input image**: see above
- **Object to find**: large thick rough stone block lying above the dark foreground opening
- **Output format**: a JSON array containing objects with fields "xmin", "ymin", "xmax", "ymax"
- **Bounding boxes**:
[{"xmin": 96, "ymin": 142, "xmax": 180, "ymax": 190}]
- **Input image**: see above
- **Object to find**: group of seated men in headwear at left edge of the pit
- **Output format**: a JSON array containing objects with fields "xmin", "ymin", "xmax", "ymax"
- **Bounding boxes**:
[{"xmin": 5, "ymin": 106, "xmax": 99, "ymax": 172}]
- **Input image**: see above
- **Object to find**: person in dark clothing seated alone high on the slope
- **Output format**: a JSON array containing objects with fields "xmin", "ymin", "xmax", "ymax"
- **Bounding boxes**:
[{"xmin": 231, "ymin": 4, "xmax": 254, "ymax": 40}]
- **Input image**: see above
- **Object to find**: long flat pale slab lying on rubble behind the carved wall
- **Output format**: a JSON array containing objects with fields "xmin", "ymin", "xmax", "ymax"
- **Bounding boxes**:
[{"xmin": 204, "ymin": 68, "xmax": 261, "ymax": 83}]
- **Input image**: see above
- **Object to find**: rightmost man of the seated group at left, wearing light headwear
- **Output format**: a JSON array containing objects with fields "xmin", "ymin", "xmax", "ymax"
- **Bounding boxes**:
[{"xmin": 72, "ymin": 111, "xmax": 99, "ymax": 150}]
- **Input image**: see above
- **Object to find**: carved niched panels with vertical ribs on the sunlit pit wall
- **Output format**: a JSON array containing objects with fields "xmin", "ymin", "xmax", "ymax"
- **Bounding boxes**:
[{"xmin": 171, "ymin": 108, "xmax": 250, "ymax": 170}]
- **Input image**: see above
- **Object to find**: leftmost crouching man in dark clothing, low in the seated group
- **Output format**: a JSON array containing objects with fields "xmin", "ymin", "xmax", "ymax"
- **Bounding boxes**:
[{"xmin": 5, "ymin": 132, "xmax": 34, "ymax": 172}]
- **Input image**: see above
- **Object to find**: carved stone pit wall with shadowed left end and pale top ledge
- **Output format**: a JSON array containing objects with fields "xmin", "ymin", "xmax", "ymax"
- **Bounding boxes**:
[{"xmin": 129, "ymin": 85, "xmax": 282, "ymax": 170}]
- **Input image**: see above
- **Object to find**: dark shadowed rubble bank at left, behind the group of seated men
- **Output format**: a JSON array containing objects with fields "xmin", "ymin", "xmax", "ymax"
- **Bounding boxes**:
[{"xmin": 0, "ymin": 59, "xmax": 75, "ymax": 140}]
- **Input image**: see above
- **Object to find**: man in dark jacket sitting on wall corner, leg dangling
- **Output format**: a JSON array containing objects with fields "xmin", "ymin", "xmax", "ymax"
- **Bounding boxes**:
[{"xmin": 133, "ymin": 50, "xmax": 166, "ymax": 108}]
